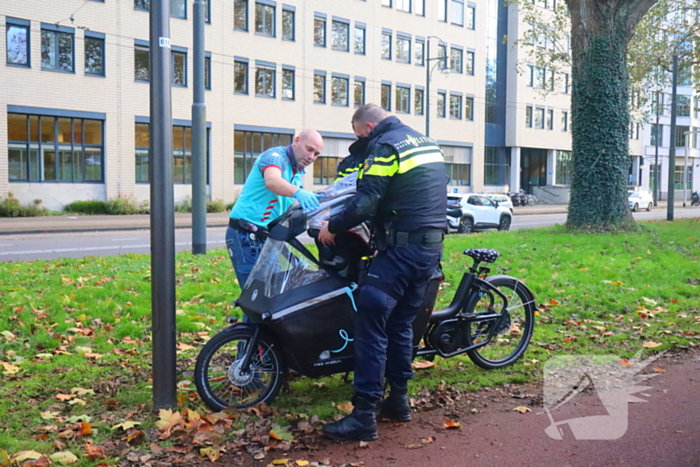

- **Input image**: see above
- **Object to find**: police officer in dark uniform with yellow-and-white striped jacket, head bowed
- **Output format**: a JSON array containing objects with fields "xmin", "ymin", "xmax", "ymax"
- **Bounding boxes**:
[{"xmin": 319, "ymin": 104, "xmax": 447, "ymax": 441}]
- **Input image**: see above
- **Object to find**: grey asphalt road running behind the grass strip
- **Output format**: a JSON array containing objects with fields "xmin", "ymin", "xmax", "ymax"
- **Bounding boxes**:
[{"xmin": 0, "ymin": 208, "xmax": 700, "ymax": 262}]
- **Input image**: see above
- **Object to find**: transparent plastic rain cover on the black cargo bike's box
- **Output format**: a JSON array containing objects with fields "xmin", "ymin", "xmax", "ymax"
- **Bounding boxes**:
[{"xmin": 245, "ymin": 172, "xmax": 357, "ymax": 298}]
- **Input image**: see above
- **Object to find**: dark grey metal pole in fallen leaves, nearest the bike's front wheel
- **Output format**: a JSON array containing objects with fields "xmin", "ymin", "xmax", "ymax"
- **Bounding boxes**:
[{"xmin": 150, "ymin": 0, "xmax": 177, "ymax": 410}]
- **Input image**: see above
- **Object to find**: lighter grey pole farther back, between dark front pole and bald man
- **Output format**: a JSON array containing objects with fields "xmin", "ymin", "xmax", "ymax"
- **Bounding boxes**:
[{"xmin": 192, "ymin": 0, "xmax": 207, "ymax": 255}]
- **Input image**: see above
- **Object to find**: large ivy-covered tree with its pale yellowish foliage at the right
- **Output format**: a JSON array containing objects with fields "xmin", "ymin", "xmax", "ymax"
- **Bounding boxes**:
[{"xmin": 517, "ymin": 0, "xmax": 700, "ymax": 230}]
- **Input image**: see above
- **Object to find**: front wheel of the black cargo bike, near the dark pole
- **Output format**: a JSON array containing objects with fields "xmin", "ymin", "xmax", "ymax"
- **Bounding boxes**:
[{"xmin": 194, "ymin": 326, "xmax": 287, "ymax": 411}]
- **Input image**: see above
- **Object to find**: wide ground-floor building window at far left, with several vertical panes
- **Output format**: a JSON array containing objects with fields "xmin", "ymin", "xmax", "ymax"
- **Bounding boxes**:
[{"xmin": 7, "ymin": 113, "xmax": 104, "ymax": 183}]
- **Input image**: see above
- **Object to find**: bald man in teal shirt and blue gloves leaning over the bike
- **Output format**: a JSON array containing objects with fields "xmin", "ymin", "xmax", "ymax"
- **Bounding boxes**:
[{"xmin": 226, "ymin": 130, "xmax": 323, "ymax": 288}]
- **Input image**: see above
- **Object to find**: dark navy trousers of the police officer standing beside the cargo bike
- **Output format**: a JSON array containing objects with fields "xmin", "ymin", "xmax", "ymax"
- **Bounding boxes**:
[{"xmin": 354, "ymin": 244, "xmax": 441, "ymax": 400}]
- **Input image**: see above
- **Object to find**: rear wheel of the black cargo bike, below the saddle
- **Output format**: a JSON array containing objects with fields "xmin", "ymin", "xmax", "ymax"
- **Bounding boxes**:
[{"xmin": 465, "ymin": 276, "xmax": 535, "ymax": 370}]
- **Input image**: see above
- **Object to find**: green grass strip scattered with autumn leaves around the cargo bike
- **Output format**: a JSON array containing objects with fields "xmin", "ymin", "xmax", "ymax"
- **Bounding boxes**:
[{"xmin": 0, "ymin": 220, "xmax": 700, "ymax": 466}]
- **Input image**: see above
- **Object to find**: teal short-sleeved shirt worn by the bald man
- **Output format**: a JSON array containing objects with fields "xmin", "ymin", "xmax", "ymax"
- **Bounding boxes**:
[{"xmin": 230, "ymin": 146, "xmax": 304, "ymax": 228}]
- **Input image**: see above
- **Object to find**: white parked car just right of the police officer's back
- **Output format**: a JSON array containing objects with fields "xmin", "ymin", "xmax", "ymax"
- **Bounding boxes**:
[{"xmin": 447, "ymin": 193, "xmax": 513, "ymax": 233}]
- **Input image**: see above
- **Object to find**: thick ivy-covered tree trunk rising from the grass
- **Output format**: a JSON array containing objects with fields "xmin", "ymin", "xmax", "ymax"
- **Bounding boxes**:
[{"xmin": 566, "ymin": 0, "xmax": 657, "ymax": 231}]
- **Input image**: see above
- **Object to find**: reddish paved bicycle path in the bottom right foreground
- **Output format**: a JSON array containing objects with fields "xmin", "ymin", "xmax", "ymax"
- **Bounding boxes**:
[{"xmin": 216, "ymin": 351, "xmax": 700, "ymax": 467}]
